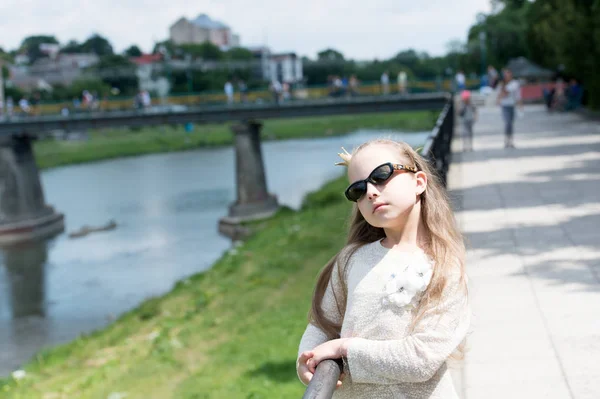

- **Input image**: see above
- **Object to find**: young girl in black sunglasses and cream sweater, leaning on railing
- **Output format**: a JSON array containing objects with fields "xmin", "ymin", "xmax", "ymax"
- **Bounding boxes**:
[{"xmin": 297, "ymin": 140, "xmax": 470, "ymax": 399}]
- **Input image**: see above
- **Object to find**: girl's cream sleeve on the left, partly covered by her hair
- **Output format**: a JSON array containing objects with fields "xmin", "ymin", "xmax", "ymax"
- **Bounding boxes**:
[{"xmin": 296, "ymin": 255, "xmax": 343, "ymax": 382}]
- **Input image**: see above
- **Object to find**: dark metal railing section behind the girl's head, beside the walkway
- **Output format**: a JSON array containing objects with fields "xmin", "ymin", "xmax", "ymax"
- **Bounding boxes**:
[{"xmin": 421, "ymin": 99, "xmax": 454, "ymax": 186}]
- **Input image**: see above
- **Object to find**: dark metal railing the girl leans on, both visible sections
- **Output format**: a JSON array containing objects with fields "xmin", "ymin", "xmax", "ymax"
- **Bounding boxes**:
[{"xmin": 302, "ymin": 99, "xmax": 454, "ymax": 399}]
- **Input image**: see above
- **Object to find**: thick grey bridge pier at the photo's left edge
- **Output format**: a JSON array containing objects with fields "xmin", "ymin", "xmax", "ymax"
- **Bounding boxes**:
[{"xmin": 0, "ymin": 135, "xmax": 64, "ymax": 245}]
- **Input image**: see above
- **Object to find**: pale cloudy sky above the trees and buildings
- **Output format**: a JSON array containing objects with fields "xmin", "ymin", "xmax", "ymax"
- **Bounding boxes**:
[{"xmin": 0, "ymin": 0, "xmax": 490, "ymax": 60}]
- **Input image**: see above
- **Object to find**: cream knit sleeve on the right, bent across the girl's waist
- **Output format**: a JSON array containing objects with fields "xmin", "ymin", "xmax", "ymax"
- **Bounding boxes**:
[{"xmin": 347, "ymin": 276, "xmax": 470, "ymax": 384}]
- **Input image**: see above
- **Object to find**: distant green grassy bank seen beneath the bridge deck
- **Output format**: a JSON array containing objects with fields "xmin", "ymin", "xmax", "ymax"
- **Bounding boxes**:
[{"xmin": 34, "ymin": 111, "xmax": 439, "ymax": 169}]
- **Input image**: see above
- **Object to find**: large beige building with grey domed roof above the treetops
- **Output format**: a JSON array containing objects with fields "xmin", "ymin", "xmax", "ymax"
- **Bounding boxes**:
[{"xmin": 169, "ymin": 14, "xmax": 240, "ymax": 49}]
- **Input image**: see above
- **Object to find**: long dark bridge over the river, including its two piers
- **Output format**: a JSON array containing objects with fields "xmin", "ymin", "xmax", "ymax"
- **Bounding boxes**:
[{"xmin": 0, "ymin": 93, "xmax": 453, "ymax": 245}]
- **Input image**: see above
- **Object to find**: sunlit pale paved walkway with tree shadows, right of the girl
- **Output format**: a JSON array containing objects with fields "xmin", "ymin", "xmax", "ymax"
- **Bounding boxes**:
[{"xmin": 449, "ymin": 106, "xmax": 600, "ymax": 399}]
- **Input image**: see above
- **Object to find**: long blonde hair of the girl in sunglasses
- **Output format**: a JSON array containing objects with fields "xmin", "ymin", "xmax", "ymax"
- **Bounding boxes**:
[{"xmin": 309, "ymin": 139, "xmax": 466, "ymax": 339}]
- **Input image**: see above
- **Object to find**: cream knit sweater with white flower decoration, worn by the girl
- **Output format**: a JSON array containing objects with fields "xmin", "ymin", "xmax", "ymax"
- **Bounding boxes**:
[{"xmin": 298, "ymin": 241, "xmax": 470, "ymax": 399}]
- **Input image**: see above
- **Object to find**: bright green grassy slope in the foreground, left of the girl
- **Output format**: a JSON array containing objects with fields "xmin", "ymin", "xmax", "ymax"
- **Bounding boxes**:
[{"xmin": 0, "ymin": 176, "xmax": 350, "ymax": 399}]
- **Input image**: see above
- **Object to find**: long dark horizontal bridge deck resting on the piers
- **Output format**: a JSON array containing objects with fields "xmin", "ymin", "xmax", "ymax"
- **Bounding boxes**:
[{"xmin": 0, "ymin": 93, "xmax": 450, "ymax": 138}]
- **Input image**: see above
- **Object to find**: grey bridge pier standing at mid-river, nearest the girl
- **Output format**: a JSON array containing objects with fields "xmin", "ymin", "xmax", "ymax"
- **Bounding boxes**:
[{"xmin": 219, "ymin": 121, "xmax": 279, "ymax": 240}]
